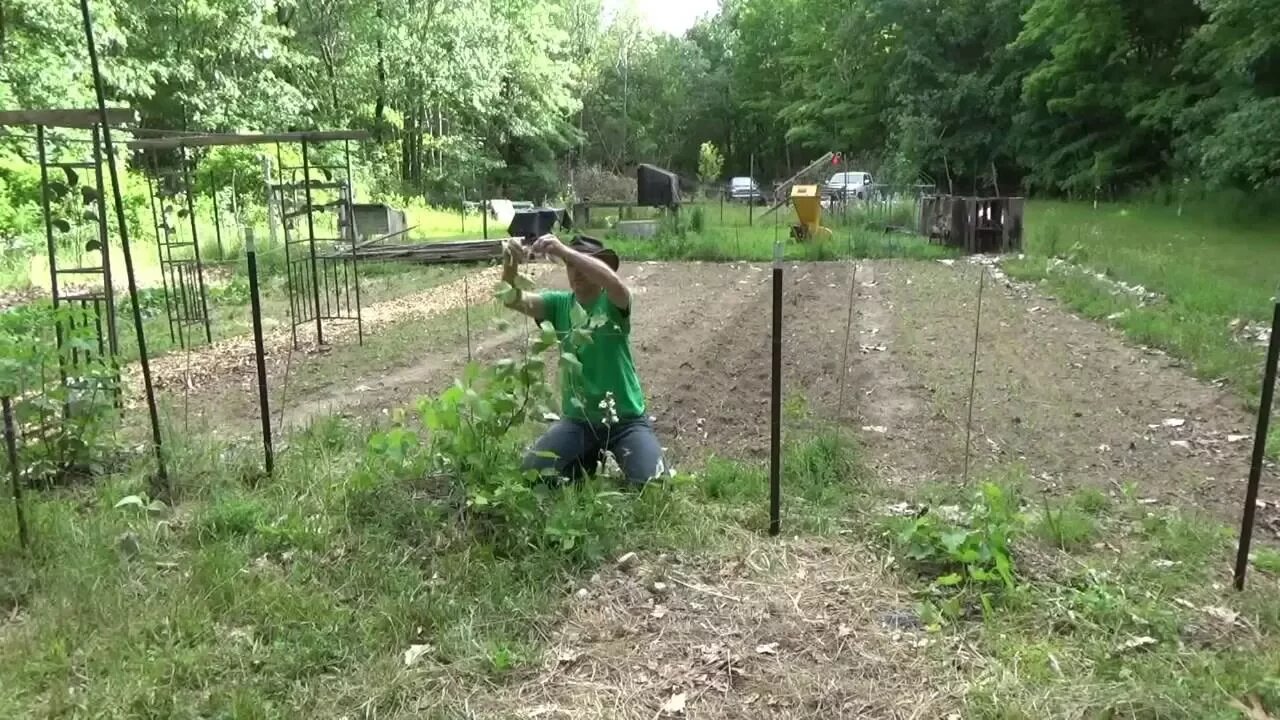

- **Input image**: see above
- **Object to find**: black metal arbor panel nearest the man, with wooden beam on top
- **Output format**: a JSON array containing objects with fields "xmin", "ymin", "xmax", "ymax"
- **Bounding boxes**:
[{"xmin": 129, "ymin": 131, "xmax": 371, "ymax": 346}]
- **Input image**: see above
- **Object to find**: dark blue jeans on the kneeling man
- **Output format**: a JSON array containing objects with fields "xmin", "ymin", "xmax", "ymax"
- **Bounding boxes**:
[{"xmin": 524, "ymin": 418, "xmax": 666, "ymax": 486}]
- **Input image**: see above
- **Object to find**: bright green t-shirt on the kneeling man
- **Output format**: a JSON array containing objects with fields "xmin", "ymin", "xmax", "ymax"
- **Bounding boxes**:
[{"xmin": 541, "ymin": 291, "xmax": 644, "ymax": 423}]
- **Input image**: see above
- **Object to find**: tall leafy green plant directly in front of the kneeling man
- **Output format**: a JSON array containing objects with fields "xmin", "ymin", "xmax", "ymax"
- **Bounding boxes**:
[{"xmin": 352, "ymin": 271, "xmax": 618, "ymax": 559}]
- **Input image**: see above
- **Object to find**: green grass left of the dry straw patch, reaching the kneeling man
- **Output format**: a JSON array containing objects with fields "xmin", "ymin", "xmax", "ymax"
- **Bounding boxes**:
[{"xmin": 0, "ymin": 397, "xmax": 859, "ymax": 717}]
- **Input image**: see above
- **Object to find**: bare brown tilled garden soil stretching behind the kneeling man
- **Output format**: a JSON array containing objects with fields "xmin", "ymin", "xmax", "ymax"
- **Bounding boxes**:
[{"xmin": 177, "ymin": 261, "xmax": 1280, "ymax": 527}]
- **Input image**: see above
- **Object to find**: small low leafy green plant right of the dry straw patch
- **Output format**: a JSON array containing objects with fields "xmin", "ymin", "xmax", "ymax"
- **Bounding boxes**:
[{"xmin": 891, "ymin": 483, "xmax": 1025, "ymax": 594}]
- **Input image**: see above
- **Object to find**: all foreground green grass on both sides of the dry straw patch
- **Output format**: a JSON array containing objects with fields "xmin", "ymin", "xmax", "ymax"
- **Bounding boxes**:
[{"xmin": 0, "ymin": 371, "xmax": 1280, "ymax": 720}]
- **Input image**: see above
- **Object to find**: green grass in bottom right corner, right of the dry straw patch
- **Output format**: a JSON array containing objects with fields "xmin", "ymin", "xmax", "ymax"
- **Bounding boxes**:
[{"xmin": 870, "ymin": 456, "xmax": 1280, "ymax": 720}]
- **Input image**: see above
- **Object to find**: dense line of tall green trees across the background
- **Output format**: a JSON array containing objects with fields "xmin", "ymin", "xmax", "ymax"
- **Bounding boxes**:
[{"xmin": 0, "ymin": 0, "xmax": 1280, "ymax": 196}]
